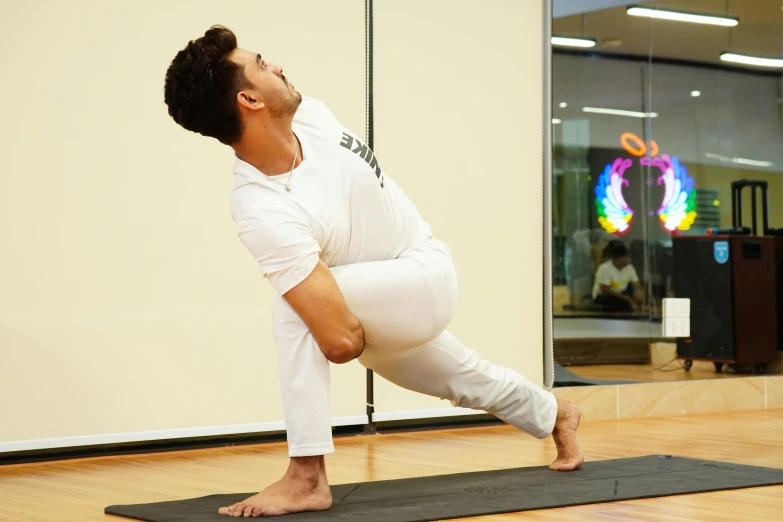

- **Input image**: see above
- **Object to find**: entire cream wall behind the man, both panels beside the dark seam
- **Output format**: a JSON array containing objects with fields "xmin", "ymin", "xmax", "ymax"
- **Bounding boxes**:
[{"xmin": 0, "ymin": 0, "xmax": 543, "ymax": 442}]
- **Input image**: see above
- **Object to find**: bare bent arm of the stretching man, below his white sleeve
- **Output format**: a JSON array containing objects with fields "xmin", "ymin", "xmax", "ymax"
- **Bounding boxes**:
[{"xmin": 283, "ymin": 260, "xmax": 364, "ymax": 364}]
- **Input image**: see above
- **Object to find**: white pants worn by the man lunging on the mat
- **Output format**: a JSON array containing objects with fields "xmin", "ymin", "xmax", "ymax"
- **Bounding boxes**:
[{"xmin": 273, "ymin": 239, "xmax": 557, "ymax": 457}]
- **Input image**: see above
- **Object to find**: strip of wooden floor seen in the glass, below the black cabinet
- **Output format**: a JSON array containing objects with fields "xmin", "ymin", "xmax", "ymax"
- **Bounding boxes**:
[{"xmin": 567, "ymin": 361, "xmax": 783, "ymax": 382}]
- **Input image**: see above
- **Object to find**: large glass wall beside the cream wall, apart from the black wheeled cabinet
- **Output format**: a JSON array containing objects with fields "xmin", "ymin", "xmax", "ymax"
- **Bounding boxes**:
[{"xmin": 552, "ymin": 0, "xmax": 783, "ymax": 385}]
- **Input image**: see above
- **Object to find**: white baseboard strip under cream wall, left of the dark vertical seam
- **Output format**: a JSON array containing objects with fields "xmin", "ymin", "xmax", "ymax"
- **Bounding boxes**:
[{"xmin": 0, "ymin": 415, "xmax": 368, "ymax": 453}]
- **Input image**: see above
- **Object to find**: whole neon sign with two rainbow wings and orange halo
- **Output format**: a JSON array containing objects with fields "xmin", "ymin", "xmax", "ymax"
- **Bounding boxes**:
[{"xmin": 595, "ymin": 132, "xmax": 697, "ymax": 236}]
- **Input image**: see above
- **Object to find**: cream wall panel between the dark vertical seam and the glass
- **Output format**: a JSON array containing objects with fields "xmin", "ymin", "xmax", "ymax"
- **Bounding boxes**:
[{"xmin": 373, "ymin": 0, "xmax": 543, "ymax": 414}]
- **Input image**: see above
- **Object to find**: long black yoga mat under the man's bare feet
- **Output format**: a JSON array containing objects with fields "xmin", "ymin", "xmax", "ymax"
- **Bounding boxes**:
[{"xmin": 106, "ymin": 455, "xmax": 783, "ymax": 522}]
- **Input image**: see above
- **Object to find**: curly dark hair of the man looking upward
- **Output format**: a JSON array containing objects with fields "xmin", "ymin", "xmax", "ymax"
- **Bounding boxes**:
[{"xmin": 164, "ymin": 25, "xmax": 251, "ymax": 145}]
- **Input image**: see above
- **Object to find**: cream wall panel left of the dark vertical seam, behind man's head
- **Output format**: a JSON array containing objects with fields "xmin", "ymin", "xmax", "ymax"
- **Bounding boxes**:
[{"xmin": 0, "ymin": 0, "xmax": 365, "ymax": 444}]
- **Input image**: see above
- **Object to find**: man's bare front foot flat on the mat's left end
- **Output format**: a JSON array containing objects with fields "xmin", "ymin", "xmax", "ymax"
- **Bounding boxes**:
[{"xmin": 218, "ymin": 458, "xmax": 332, "ymax": 517}]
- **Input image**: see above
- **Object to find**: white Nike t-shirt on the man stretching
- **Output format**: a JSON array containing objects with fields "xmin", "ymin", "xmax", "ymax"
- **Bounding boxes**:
[{"xmin": 231, "ymin": 97, "xmax": 432, "ymax": 295}]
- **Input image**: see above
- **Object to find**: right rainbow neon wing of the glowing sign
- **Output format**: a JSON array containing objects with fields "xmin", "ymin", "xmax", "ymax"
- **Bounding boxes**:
[{"xmin": 640, "ymin": 154, "xmax": 697, "ymax": 233}]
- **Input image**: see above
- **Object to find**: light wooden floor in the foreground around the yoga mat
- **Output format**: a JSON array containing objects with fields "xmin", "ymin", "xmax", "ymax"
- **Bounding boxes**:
[{"xmin": 0, "ymin": 410, "xmax": 783, "ymax": 522}]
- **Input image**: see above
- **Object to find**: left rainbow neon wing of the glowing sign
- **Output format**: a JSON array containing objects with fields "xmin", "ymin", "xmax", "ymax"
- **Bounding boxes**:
[{"xmin": 595, "ymin": 158, "xmax": 633, "ymax": 235}]
